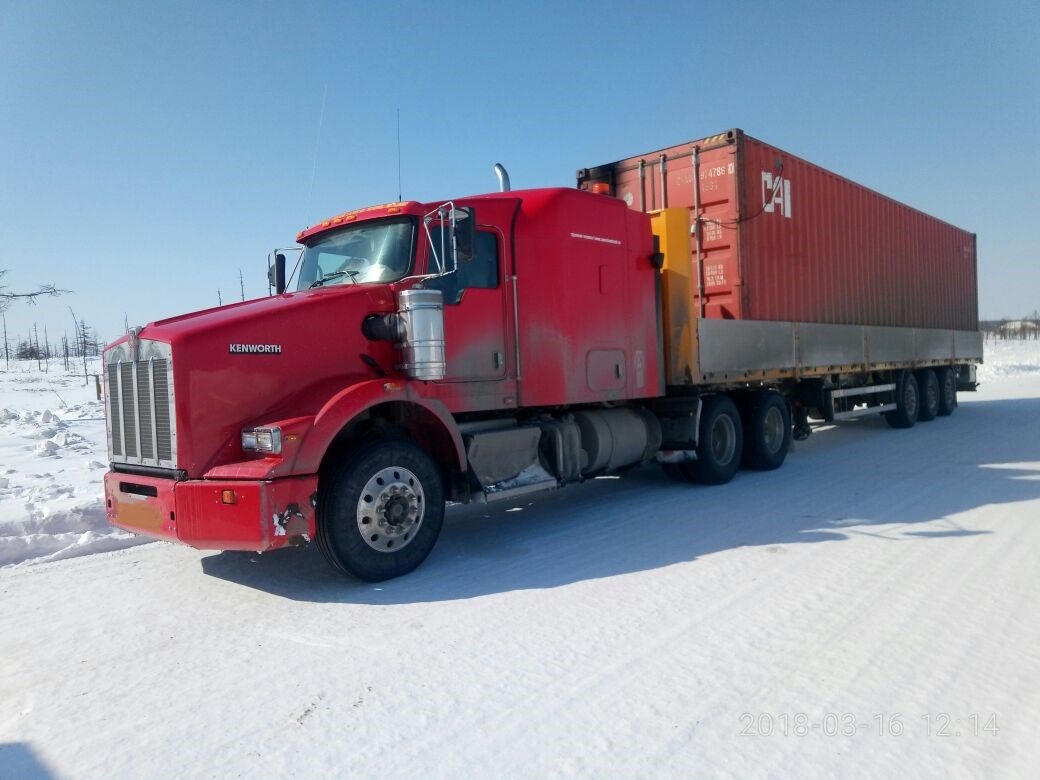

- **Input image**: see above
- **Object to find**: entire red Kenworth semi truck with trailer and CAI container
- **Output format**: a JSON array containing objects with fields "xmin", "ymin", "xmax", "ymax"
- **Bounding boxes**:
[{"xmin": 104, "ymin": 130, "xmax": 982, "ymax": 580}]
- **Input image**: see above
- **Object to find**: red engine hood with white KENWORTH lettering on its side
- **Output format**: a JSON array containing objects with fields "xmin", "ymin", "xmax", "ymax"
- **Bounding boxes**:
[{"xmin": 109, "ymin": 285, "xmax": 394, "ymax": 477}]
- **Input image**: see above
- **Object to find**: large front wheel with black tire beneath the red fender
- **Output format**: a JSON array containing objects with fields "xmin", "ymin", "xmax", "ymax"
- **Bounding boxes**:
[{"xmin": 317, "ymin": 438, "xmax": 444, "ymax": 582}]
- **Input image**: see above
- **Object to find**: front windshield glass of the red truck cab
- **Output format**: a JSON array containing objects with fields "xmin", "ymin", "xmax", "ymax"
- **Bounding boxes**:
[{"xmin": 296, "ymin": 217, "xmax": 415, "ymax": 290}]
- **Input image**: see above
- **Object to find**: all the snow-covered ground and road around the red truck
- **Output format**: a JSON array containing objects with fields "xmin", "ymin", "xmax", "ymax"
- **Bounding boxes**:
[{"xmin": 0, "ymin": 342, "xmax": 1040, "ymax": 778}]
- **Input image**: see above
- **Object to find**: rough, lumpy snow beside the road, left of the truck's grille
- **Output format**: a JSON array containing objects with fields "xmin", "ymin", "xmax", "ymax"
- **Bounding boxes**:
[{"xmin": 0, "ymin": 361, "xmax": 142, "ymax": 566}]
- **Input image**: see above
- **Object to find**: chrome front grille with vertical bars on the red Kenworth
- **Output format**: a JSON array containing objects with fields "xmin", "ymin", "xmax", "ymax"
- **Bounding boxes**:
[{"xmin": 105, "ymin": 341, "xmax": 177, "ymax": 468}]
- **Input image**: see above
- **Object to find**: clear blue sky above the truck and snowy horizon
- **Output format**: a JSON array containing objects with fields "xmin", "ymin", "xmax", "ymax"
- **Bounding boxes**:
[{"xmin": 0, "ymin": 0, "xmax": 1040, "ymax": 339}]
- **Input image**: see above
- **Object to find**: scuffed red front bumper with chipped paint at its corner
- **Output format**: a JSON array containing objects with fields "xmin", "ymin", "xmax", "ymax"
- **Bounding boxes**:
[{"xmin": 105, "ymin": 471, "xmax": 317, "ymax": 552}]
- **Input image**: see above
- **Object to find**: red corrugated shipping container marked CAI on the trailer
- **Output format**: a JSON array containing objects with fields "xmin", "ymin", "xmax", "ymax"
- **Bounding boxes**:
[{"xmin": 578, "ymin": 130, "xmax": 979, "ymax": 331}]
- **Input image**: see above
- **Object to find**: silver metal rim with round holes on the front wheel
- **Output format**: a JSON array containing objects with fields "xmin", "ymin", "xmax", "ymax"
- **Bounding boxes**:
[{"xmin": 358, "ymin": 466, "xmax": 426, "ymax": 552}]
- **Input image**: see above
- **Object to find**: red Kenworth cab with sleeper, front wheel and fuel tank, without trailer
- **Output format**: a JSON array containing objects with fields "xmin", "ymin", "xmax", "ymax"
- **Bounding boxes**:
[{"xmin": 104, "ymin": 188, "xmax": 665, "ymax": 579}]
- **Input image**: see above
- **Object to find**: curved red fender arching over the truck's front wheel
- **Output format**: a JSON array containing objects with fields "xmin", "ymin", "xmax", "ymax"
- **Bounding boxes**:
[{"xmin": 291, "ymin": 379, "xmax": 466, "ymax": 474}]
